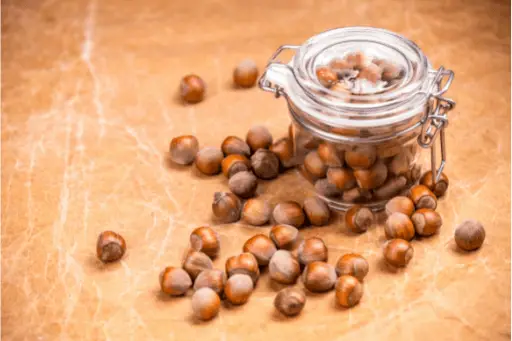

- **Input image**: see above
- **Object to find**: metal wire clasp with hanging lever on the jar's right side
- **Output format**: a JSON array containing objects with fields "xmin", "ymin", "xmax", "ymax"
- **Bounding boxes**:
[{"xmin": 418, "ymin": 66, "xmax": 455, "ymax": 184}]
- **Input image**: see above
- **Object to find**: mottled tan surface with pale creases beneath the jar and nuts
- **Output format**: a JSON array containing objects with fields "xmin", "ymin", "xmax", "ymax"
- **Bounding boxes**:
[{"xmin": 2, "ymin": 0, "xmax": 510, "ymax": 341}]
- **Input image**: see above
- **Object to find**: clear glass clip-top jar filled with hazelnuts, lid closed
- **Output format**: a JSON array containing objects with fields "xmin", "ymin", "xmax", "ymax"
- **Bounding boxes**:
[{"xmin": 259, "ymin": 27, "xmax": 455, "ymax": 210}]
